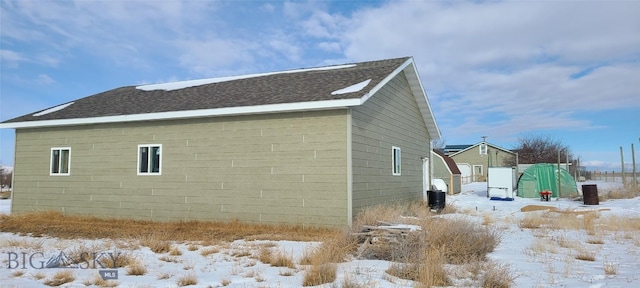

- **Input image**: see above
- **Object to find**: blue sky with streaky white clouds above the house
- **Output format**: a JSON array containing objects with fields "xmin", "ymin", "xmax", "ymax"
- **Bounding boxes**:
[{"xmin": 0, "ymin": 0, "xmax": 640, "ymax": 171}]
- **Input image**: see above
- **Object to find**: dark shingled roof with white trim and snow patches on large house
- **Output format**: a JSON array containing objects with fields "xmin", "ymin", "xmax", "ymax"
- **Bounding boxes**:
[{"xmin": 0, "ymin": 57, "xmax": 440, "ymax": 138}]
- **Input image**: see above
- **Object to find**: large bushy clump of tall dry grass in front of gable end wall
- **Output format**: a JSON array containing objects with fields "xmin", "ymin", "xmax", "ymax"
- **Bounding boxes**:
[{"xmin": 350, "ymin": 204, "xmax": 500, "ymax": 287}]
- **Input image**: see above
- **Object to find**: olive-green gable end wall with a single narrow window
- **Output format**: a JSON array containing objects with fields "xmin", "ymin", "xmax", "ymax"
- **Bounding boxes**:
[{"xmin": 351, "ymin": 73, "xmax": 430, "ymax": 215}]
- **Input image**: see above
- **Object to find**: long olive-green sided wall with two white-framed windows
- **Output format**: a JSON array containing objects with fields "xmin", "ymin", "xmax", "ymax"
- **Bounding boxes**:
[{"xmin": 12, "ymin": 110, "xmax": 348, "ymax": 226}]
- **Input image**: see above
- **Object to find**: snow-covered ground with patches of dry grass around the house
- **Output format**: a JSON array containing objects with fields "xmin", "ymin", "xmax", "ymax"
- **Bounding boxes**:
[{"xmin": 0, "ymin": 182, "xmax": 640, "ymax": 287}]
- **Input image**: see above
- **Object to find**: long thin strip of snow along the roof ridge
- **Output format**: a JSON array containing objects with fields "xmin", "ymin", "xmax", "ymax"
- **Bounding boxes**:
[{"xmin": 136, "ymin": 64, "xmax": 358, "ymax": 91}]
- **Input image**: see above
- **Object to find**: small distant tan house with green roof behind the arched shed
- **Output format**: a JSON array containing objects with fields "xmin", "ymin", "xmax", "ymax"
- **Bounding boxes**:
[{"xmin": 443, "ymin": 141, "xmax": 517, "ymax": 183}]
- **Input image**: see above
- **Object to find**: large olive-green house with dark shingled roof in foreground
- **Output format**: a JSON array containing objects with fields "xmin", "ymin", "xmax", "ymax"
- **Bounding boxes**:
[{"xmin": 0, "ymin": 57, "xmax": 440, "ymax": 226}]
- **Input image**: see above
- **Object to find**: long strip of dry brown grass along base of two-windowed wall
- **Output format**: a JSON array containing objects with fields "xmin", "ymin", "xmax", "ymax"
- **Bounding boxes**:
[{"xmin": 0, "ymin": 211, "xmax": 336, "ymax": 242}]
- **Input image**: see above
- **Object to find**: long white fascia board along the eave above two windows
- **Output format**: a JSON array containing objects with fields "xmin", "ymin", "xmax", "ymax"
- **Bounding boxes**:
[{"xmin": 0, "ymin": 98, "xmax": 361, "ymax": 129}]
